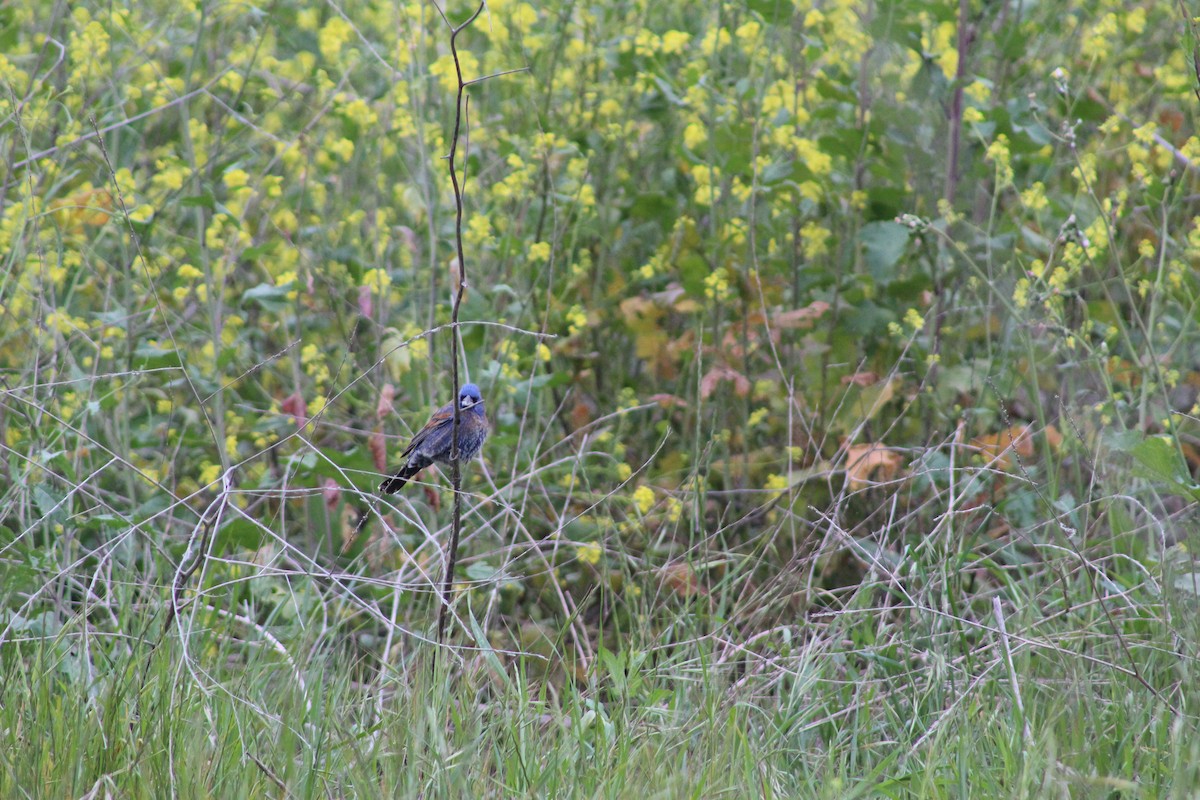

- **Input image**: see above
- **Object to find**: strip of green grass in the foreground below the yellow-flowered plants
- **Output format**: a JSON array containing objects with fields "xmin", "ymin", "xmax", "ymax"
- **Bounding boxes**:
[{"xmin": 0, "ymin": 575, "xmax": 1198, "ymax": 798}]
